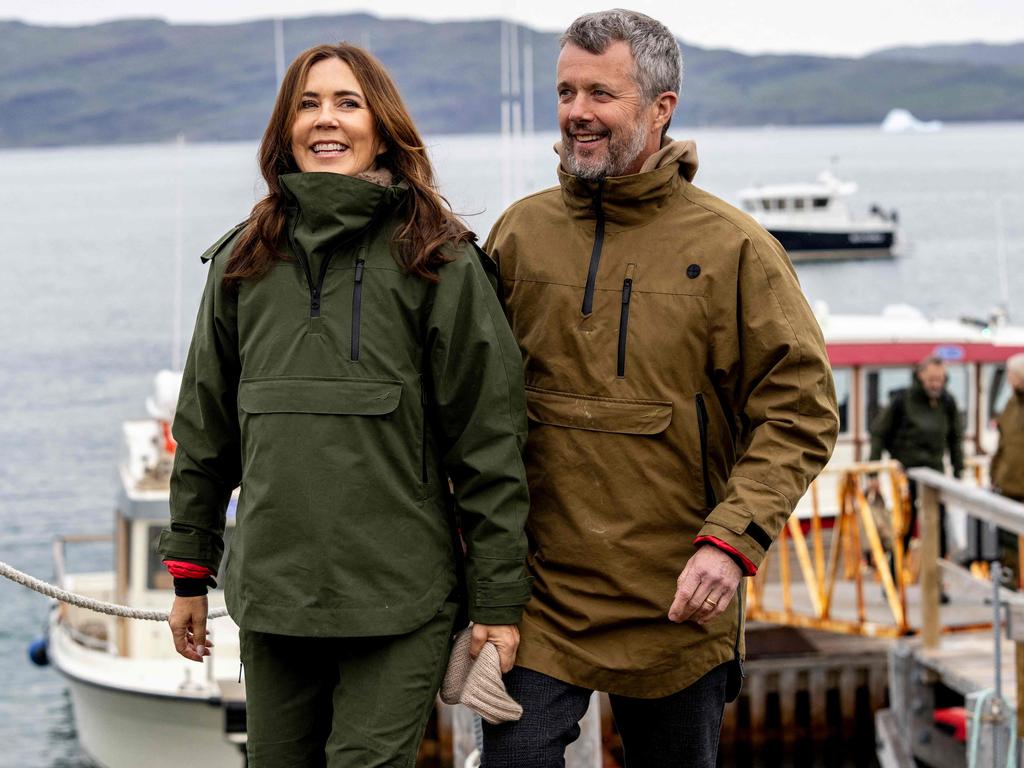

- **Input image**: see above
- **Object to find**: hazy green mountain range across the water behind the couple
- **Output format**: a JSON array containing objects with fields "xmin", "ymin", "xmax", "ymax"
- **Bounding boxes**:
[{"xmin": 0, "ymin": 14, "xmax": 1024, "ymax": 146}]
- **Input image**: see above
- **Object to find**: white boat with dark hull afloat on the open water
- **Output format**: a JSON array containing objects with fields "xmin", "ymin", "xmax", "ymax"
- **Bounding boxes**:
[{"xmin": 738, "ymin": 171, "xmax": 898, "ymax": 261}]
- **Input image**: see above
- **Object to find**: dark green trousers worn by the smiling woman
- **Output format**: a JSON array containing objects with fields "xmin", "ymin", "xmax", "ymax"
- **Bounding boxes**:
[{"xmin": 240, "ymin": 602, "xmax": 459, "ymax": 768}]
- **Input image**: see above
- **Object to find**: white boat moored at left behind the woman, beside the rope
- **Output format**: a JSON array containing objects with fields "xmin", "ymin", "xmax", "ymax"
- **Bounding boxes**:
[{"xmin": 47, "ymin": 372, "xmax": 245, "ymax": 768}]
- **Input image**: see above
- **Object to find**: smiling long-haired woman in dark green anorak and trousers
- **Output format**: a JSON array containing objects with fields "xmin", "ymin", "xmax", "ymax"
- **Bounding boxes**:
[{"xmin": 160, "ymin": 45, "xmax": 529, "ymax": 768}]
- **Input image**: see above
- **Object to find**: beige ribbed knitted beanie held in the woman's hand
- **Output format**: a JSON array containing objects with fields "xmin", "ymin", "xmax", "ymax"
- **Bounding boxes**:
[{"xmin": 441, "ymin": 628, "xmax": 522, "ymax": 725}]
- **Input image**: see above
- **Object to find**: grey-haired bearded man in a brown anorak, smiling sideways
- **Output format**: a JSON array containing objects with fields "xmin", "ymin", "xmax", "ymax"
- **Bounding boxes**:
[{"xmin": 483, "ymin": 10, "xmax": 838, "ymax": 768}]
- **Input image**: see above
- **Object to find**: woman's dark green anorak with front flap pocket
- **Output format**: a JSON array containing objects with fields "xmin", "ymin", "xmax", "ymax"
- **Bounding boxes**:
[{"xmin": 160, "ymin": 173, "xmax": 529, "ymax": 637}]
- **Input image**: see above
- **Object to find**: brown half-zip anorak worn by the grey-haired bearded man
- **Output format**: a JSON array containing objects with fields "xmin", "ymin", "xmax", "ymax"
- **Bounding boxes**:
[{"xmin": 485, "ymin": 142, "xmax": 838, "ymax": 697}]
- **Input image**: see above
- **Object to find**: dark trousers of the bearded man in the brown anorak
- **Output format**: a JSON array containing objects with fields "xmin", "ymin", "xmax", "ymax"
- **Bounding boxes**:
[{"xmin": 481, "ymin": 665, "xmax": 728, "ymax": 768}]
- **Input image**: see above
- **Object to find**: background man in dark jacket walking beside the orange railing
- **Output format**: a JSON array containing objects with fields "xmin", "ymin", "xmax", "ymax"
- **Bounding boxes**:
[{"xmin": 868, "ymin": 357, "xmax": 964, "ymax": 565}]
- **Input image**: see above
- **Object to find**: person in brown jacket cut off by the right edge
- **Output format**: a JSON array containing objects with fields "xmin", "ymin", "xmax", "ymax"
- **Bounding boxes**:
[{"xmin": 989, "ymin": 352, "xmax": 1024, "ymax": 585}]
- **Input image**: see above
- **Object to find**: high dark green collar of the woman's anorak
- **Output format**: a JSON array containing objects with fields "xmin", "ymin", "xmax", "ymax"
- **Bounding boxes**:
[{"xmin": 280, "ymin": 173, "xmax": 409, "ymax": 257}]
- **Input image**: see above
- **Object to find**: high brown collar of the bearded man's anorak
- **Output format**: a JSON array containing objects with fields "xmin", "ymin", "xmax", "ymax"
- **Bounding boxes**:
[{"xmin": 555, "ymin": 137, "xmax": 697, "ymax": 228}]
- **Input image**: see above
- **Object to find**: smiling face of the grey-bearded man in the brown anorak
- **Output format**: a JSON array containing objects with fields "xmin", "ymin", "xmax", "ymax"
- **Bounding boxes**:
[{"xmin": 556, "ymin": 40, "xmax": 664, "ymax": 180}]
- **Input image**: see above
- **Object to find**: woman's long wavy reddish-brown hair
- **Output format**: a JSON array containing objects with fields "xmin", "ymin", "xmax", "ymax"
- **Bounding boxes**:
[{"xmin": 223, "ymin": 43, "xmax": 475, "ymax": 290}]
